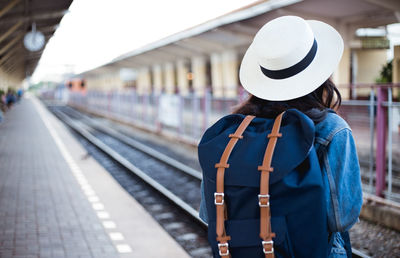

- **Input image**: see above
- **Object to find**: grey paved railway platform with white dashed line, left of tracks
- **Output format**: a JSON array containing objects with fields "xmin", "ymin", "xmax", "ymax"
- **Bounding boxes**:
[{"xmin": 0, "ymin": 97, "xmax": 189, "ymax": 258}]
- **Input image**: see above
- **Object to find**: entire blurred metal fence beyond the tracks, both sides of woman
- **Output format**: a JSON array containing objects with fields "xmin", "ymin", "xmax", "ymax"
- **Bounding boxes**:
[{"xmin": 42, "ymin": 84, "xmax": 400, "ymax": 201}]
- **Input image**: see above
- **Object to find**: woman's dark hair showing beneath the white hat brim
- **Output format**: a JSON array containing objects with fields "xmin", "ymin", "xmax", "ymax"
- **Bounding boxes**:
[{"xmin": 233, "ymin": 79, "xmax": 342, "ymax": 123}]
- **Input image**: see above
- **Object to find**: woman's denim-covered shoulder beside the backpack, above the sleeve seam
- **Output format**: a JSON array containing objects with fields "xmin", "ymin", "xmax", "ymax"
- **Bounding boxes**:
[{"xmin": 315, "ymin": 112, "xmax": 351, "ymax": 143}]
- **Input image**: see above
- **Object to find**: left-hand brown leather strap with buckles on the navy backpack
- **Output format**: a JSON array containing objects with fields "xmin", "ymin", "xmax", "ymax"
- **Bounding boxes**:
[{"xmin": 214, "ymin": 116, "xmax": 254, "ymax": 256}]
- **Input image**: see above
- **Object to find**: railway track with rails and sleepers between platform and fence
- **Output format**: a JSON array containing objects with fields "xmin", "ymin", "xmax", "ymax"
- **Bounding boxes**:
[{"xmin": 50, "ymin": 107, "xmax": 369, "ymax": 257}]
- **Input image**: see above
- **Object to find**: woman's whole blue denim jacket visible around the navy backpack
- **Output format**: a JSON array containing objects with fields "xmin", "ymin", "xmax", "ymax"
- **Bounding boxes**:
[{"xmin": 199, "ymin": 113, "xmax": 362, "ymax": 257}]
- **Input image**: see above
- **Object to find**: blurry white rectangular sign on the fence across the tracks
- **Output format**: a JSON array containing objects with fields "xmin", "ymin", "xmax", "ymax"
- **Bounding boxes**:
[{"xmin": 158, "ymin": 94, "xmax": 180, "ymax": 128}]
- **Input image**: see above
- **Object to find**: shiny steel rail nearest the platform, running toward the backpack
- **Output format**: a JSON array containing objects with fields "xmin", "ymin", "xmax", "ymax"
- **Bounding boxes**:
[{"xmin": 55, "ymin": 111, "xmax": 207, "ymax": 227}]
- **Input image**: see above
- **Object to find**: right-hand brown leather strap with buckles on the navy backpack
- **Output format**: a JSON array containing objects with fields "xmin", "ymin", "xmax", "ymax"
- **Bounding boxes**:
[{"xmin": 258, "ymin": 112, "xmax": 285, "ymax": 258}]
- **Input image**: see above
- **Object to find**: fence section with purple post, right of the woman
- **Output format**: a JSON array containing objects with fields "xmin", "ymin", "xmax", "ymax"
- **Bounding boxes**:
[{"xmin": 339, "ymin": 85, "xmax": 400, "ymax": 201}]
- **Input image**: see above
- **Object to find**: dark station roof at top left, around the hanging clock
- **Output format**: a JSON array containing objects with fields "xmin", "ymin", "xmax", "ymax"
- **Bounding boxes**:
[{"xmin": 0, "ymin": 0, "xmax": 72, "ymax": 81}]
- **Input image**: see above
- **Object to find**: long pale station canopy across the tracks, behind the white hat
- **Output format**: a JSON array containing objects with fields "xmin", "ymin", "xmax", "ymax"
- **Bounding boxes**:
[{"xmin": 81, "ymin": 0, "xmax": 400, "ymax": 77}]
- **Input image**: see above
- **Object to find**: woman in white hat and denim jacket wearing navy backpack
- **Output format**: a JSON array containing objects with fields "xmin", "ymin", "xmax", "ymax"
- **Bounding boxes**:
[{"xmin": 198, "ymin": 16, "xmax": 362, "ymax": 258}]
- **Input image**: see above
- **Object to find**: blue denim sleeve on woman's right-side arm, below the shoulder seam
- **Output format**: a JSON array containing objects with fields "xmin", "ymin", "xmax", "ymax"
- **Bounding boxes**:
[{"xmin": 323, "ymin": 128, "xmax": 362, "ymax": 232}]
